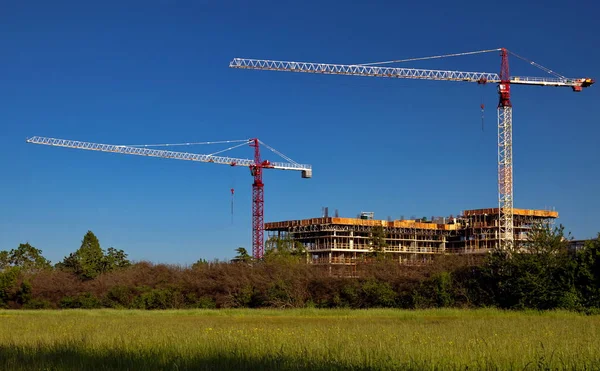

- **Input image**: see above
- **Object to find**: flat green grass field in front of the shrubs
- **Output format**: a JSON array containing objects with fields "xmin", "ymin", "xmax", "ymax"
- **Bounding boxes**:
[{"xmin": 0, "ymin": 309, "xmax": 600, "ymax": 370}]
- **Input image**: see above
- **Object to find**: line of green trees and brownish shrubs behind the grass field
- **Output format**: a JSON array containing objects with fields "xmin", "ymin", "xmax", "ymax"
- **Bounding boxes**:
[{"xmin": 0, "ymin": 225, "xmax": 600, "ymax": 312}]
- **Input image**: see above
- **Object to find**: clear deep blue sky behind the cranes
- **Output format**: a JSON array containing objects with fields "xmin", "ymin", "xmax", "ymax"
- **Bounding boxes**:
[{"xmin": 0, "ymin": 0, "xmax": 600, "ymax": 264}]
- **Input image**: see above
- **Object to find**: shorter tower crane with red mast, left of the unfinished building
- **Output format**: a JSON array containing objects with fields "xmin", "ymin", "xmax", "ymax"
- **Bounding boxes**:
[{"xmin": 26, "ymin": 136, "xmax": 312, "ymax": 259}]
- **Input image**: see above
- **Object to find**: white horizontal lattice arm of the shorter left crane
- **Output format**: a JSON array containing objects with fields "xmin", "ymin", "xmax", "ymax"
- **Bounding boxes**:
[{"xmin": 27, "ymin": 136, "xmax": 311, "ymax": 173}]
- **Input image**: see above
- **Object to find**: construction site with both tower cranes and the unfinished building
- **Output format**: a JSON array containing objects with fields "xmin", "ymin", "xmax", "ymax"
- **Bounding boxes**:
[{"xmin": 27, "ymin": 48, "xmax": 595, "ymax": 265}]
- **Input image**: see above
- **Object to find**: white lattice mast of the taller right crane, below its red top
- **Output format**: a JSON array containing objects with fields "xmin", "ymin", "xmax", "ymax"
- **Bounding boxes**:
[{"xmin": 498, "ymin": 107, "xmax": 514, "ymax": 251}]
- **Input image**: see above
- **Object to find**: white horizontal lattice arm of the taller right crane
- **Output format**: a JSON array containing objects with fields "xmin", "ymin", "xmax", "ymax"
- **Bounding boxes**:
[{"xmin": 229, "ymin": 58, "xmax": 594, "ymax": 88}]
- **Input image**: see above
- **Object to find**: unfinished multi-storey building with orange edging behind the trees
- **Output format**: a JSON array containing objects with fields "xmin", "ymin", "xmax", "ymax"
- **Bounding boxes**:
[{"xmin": 265, "ymin": 208, "xmax": 558, "ymax": 265}]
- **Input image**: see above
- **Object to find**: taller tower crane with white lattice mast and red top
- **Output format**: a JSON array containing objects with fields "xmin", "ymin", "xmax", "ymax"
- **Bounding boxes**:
[{"xmin": 229, "ymin": 48, "xmax": 595, "ymax": 250}]
